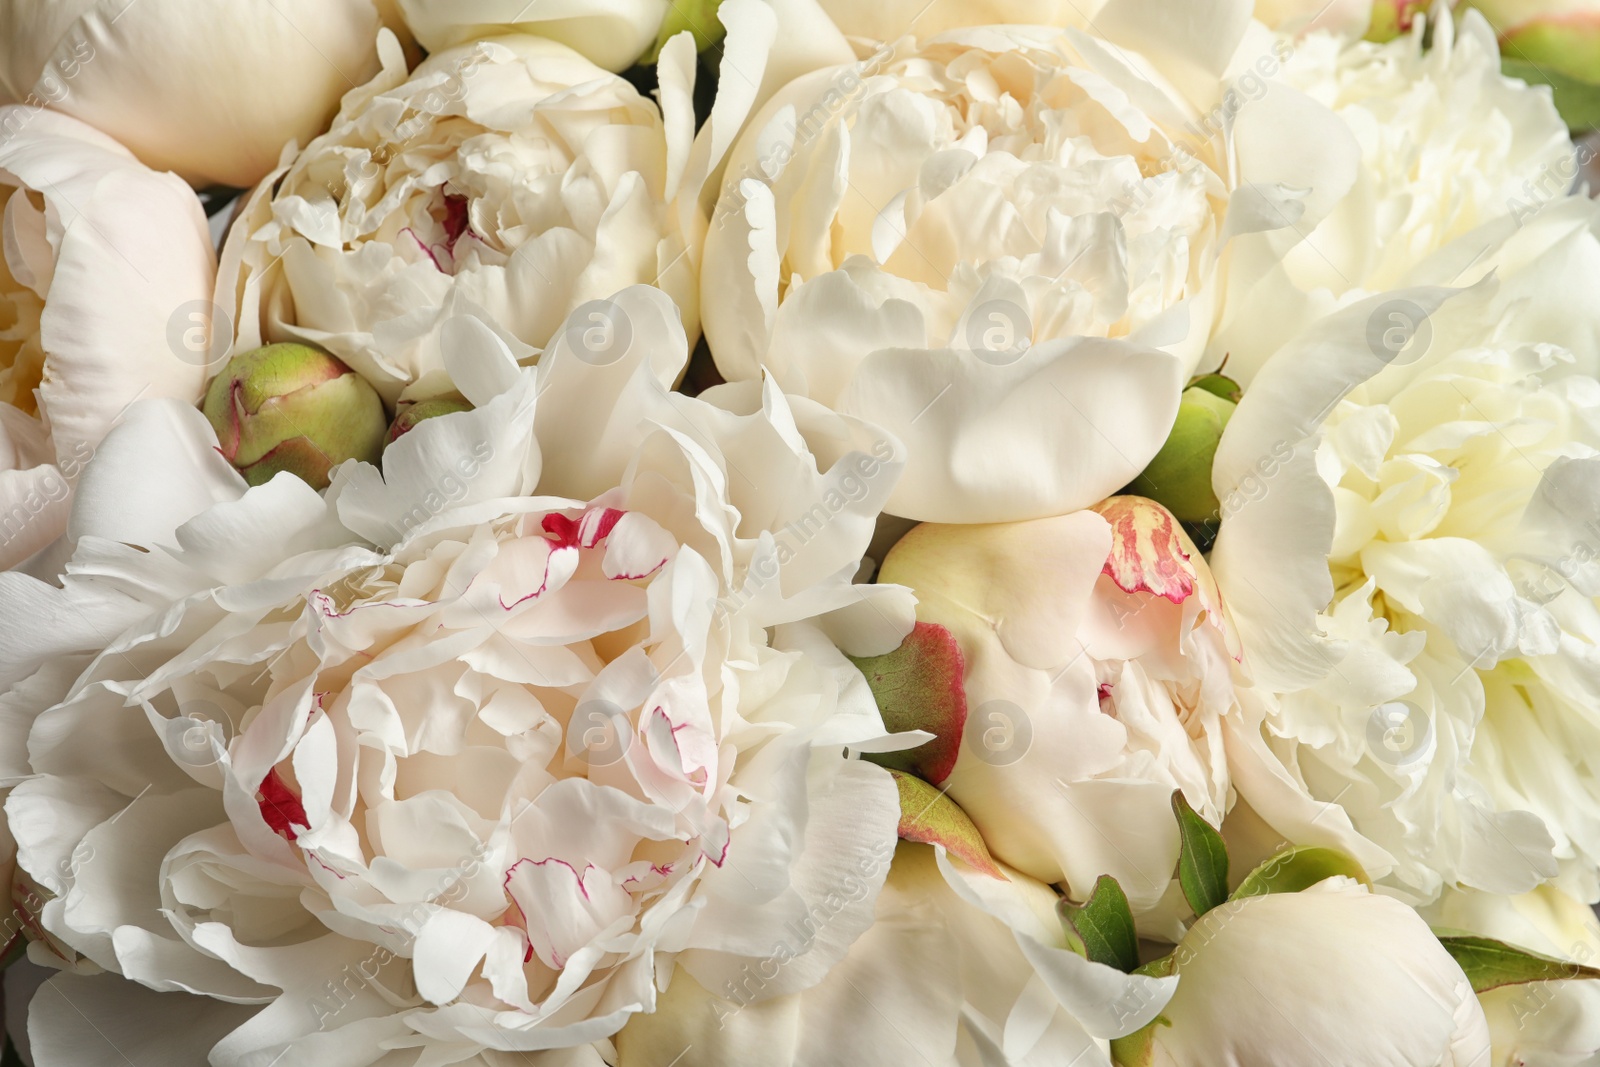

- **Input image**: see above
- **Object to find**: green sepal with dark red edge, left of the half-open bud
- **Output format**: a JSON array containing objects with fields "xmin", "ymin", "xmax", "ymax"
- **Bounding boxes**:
[{"xmin": 850, "ymin": 622, "xmax": 966, "ymax": 785}]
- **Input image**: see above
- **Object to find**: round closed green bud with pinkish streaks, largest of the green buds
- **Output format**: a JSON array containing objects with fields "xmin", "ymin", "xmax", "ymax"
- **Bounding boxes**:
[{"xmin": 202, "ymin": 344, "xmax": 387, "ymax": 490}]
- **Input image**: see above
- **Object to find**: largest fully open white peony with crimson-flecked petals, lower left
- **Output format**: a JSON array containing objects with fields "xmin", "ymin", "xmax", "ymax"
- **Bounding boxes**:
[{"xmin": 0, "ymin": 288, "xmax": 910, "ymax": 1067}]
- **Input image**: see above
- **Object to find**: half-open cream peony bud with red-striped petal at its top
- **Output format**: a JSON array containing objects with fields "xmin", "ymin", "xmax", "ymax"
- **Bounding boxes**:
[{"xmin": 880, "ymin": 498, "xmax": 1260, "ymax": 913}]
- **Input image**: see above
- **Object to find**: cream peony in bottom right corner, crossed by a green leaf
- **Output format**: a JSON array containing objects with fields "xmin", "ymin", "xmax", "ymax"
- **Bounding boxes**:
[{"xmin": 1429, "ymin": 886, "xmax": 1600, "ymax": 1067}]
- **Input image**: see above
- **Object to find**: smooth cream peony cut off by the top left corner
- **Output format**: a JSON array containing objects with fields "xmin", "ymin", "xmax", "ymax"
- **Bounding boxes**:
[{"xmin": 0, "ymin": 0, "xmax": 406, "ymax": 186}]
